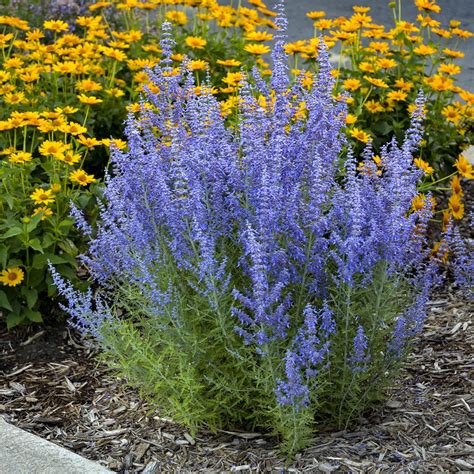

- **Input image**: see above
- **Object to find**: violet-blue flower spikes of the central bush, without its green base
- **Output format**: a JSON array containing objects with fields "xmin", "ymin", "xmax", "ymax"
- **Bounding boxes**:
[{"xmin": 55, "ymin": 11, "xmax": 436, "ymax": 416}]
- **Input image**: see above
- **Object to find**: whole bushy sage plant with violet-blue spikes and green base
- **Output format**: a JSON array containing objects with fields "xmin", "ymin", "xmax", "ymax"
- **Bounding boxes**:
[{"xmin": 53, "ymin": 14, "xmax": 439, "ymax": 453}]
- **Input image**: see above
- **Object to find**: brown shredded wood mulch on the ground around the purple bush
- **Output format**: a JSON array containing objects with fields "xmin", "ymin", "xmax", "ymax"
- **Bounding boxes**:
[{"xmin": 0, "ymin": 290, "xmax": 474, "ymax": 474}]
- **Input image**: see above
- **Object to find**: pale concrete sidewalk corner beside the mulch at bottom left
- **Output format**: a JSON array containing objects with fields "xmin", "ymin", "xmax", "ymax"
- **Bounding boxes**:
[{"xmin": 0, "ymin": 416, "xmax": 112, "ymax": 474}]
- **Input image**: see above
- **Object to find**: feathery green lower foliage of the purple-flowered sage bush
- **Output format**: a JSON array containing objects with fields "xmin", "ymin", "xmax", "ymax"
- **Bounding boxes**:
[{"xmin": 94, "ymin": 260, "xmax": 410, "ymax": 456}]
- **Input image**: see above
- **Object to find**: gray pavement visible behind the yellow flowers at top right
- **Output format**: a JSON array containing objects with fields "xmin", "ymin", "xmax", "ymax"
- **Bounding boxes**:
[{"xmin": 266, "ymin": 0, "xmax": 474, "ymax": 91}]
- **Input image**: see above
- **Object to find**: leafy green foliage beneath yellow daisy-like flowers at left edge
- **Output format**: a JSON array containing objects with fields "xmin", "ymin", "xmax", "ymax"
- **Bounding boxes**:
[{"xmin": 0, "ymin": 150, "xmax": 97, "ymax": 328}]
